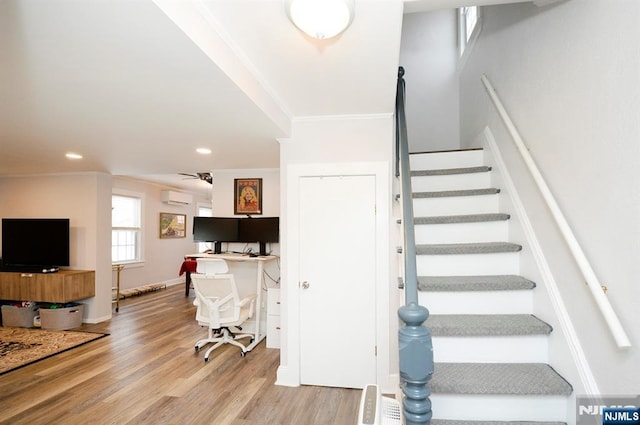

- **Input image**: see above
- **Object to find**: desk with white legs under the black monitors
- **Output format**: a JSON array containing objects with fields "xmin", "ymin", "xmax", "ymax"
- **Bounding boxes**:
[{"xmin": 184, "ymin": 254, "xmax": 278, "ymax": 351}]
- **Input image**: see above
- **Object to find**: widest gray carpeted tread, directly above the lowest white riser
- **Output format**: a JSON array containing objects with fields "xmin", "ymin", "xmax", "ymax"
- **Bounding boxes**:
[{"xmin": 429, "ymin": 363, "xmax": 573, "ymax": 395}]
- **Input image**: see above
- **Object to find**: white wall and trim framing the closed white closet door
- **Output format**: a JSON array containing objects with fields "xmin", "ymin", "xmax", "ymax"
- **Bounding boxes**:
[{"xmin": 277, "ymin": 114, "xmax": 398, "ymax": 391}]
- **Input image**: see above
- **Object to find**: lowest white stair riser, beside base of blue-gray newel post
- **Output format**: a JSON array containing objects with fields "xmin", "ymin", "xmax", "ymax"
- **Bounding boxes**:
[{"xmin": 431, "ymin": 394, "xmax": 568, "ymax": 422}]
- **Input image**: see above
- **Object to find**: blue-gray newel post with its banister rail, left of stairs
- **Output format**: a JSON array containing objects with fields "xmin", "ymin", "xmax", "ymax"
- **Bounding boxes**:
[{"xmin": 396, "ymin": 67, "xmax": 433, "ymax": 425}]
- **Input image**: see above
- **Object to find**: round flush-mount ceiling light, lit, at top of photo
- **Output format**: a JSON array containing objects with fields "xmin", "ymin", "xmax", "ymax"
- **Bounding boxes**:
[{"xmin": 285, "ymin": 0, "xmax": 355, "ymax": 40}]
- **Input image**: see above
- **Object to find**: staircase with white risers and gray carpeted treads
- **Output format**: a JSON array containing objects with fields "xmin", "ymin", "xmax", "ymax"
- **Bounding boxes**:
[{"xmin": 410, "ymin": 150, "xmax": 572, "ymax": 425}]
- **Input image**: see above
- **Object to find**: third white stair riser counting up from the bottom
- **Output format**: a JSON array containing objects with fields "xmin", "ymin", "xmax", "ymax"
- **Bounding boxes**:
[{"xmin": 418, "ymin": 291, "xmax": 533, "ymax": 314}]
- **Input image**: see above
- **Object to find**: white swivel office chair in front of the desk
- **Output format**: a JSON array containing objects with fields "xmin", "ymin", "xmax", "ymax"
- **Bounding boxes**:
[{"xmin": 191, "ymin": 260, "xmax": 256, "ymax": 362}]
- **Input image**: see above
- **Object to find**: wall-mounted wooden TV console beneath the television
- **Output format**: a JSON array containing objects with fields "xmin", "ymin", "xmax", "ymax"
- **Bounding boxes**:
[{"xmin": 0, "ymin": 270, "xmax": 96, "ymax": 303}]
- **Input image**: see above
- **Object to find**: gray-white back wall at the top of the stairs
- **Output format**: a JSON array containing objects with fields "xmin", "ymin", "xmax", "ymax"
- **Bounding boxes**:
[{"xmin": 400, "ymin": 9, "xmax": 460, "ymax": 152}]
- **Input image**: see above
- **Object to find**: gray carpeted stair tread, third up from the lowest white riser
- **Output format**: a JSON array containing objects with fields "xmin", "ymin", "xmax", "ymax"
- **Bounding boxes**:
[{"xmin": 418, "ymin": 275, "xmax": 536, "ymax": 292}]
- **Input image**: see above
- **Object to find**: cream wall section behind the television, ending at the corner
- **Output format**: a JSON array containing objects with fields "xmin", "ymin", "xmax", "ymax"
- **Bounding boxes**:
[{"xmin": 0, "ymin": 173, "xmax": 111, "ymax": 322}]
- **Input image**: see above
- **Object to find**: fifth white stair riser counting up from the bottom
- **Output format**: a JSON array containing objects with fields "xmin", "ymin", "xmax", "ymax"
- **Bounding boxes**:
[{"xmin": 415, "ymin": 220, "xmax": 509, "ymax": 244}]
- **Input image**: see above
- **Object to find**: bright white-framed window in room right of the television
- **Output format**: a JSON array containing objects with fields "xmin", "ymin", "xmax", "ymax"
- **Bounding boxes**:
[{"xmin": 111, "ymin": 194, "xmax": 142, "ymax": 263}]
